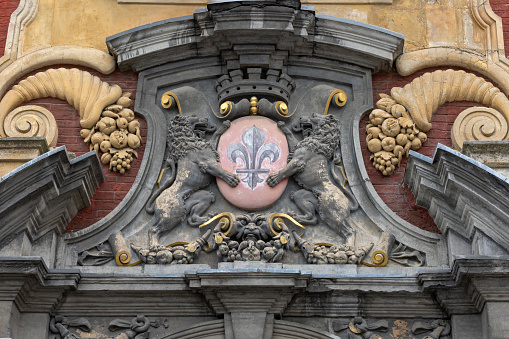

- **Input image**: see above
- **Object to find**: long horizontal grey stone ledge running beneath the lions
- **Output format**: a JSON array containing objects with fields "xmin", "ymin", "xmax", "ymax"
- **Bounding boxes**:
[{"xmin": 0, "ymin": 256, "xmax": 509, "ymax": 339}]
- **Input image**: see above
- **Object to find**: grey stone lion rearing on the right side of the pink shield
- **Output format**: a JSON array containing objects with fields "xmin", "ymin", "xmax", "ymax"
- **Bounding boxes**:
[{"xmin": 267, "ymin": 114, "xmax": 358, "ymax": 247}]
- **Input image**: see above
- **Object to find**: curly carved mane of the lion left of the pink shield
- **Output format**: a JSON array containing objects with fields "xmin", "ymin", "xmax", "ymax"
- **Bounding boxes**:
[{"xmin": 166, "ymin": 115, "xmax": 219, "ymax": 162}]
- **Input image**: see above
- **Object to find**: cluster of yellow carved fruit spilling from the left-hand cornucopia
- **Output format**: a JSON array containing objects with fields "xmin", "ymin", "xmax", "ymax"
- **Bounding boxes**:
[{"xmin": 80, "ymin": 93, "xmax": 141, "ymax": 174}]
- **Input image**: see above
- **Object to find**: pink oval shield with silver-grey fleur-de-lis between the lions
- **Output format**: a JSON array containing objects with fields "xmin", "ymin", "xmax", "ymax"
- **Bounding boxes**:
[{"xmin": 217, "ymin": 116, "xmax": 288, "ymax": 210}]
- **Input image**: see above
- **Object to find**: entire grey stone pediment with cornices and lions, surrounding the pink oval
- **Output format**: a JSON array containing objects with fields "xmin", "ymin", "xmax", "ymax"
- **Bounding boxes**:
[{"xmin": 0, "ymin": 0, "xmax": 509, "ymax": 339}]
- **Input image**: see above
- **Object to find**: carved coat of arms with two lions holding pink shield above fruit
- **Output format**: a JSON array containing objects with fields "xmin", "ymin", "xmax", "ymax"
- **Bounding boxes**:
[{"xmin": 116, "ymin": 98, "xmax": 425, "ymax": 266}]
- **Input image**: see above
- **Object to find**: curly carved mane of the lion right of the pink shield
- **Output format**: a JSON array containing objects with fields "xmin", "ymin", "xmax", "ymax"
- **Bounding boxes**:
[{"xmin": 288, "ymin": 115, "xmax": 340, "ymax": 161}]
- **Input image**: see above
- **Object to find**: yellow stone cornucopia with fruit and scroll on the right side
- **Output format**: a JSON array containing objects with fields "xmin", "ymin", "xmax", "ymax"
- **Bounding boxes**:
[{"xmin": 366, "ymin": 69, "xmax": 509, "ymax": 175}]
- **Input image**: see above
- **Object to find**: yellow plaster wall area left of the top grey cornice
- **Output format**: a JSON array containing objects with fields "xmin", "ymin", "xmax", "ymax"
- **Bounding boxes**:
[{"xmin": 23, "ymin": 0, "xmax": 196, "ymax": 52}]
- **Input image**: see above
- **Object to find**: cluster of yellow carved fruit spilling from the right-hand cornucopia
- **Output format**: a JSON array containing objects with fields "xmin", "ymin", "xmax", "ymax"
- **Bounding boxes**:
[{"xmin": 366, "ymin": 94, "xmax": 427, "ymax": 175}]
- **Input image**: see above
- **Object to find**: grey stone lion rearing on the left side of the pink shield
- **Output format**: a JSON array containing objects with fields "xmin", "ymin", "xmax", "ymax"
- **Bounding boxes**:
[{"xmin": 146, "ymin": 116, "xmax": 239, "ymax": 252}]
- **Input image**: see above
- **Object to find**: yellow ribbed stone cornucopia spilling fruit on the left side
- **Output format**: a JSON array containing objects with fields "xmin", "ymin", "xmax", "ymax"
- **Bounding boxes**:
[{"xmin": 0, "ymin": 68, "xmax": 141, "ymax": 174}]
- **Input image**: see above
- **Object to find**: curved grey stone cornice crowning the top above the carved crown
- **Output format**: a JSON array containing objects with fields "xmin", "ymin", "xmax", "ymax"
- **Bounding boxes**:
[{"xmin": 106, "ymin": 1, "xmax": 403, "ymax": 72}]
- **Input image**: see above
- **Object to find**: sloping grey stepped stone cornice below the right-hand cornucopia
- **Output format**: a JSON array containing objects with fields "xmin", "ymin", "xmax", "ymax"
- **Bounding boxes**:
[{"xmin": 404, "ymin": 144, "xmax": 509, "ymax": 255}]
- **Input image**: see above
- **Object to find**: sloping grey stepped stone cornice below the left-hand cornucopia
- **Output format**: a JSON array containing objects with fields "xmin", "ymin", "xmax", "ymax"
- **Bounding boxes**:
[{"xmin": 0, "ymin": 146, "xmax": 104, "ymax": 244}]
